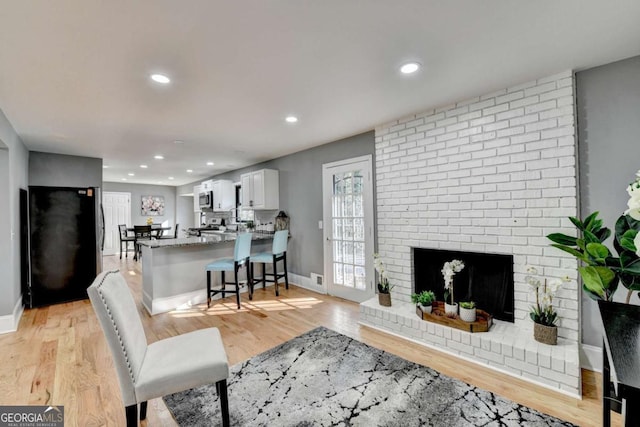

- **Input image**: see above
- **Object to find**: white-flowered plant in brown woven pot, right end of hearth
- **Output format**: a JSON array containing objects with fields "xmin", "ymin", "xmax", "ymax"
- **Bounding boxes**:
[{"xmin": 524, "ymin": 267, "xmax": 571, "ymax": 345}]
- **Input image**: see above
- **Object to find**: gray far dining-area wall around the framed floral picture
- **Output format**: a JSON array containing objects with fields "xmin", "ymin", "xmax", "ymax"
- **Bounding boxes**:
[{"xmin": 102, "ymin": 182, "xmax": 178, "ymax": 228}]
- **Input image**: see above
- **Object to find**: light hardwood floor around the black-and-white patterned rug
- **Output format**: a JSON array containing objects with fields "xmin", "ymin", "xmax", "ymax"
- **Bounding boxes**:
[{"xmin": 0, "ymin": 256, "xmax": 621, "ymax": 426}]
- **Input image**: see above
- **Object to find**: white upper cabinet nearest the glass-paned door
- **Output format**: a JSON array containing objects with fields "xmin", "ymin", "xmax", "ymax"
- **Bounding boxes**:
[{"xmin": 240, "ymin": 169, "xmax": 280, "ymax": 210}]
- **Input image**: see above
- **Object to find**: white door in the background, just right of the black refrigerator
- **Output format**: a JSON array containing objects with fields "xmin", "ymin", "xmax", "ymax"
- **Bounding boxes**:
[{"xmin": 102, "ymin": 191, "xmax": 131, "ymax": 255}]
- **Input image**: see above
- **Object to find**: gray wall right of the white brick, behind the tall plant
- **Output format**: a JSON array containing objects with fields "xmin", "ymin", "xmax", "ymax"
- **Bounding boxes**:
[{"xmin": 576, "ymin": 56, "xmax": 640, "ymax": 346}]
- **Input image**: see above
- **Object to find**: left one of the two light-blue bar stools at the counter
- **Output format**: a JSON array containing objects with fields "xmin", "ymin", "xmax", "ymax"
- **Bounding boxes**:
[{"xmin": 205, "ymin": 233, "xmax": 253, "ymax": 309}]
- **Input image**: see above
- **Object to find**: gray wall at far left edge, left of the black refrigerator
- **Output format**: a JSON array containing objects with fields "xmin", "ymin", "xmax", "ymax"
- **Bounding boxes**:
[{"xmin": 0, "ymin": 110, "xmax": 29, "ymax": 316}]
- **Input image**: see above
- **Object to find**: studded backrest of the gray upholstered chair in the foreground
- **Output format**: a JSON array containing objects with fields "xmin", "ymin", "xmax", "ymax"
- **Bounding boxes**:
[{"xmin": 87, "ymin": 270, "xmax": 147, "ymax": 406}]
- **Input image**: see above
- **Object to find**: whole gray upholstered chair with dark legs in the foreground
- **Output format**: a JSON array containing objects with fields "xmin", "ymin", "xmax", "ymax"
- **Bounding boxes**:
[{"xmin": 87, "ymin": 270, "xmax": 229, "ymax": 426}]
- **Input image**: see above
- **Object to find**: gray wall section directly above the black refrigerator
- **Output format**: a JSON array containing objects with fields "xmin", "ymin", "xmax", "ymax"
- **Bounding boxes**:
[{"xmin": 29, "ymin": 151, "xmax": 102, "ymax": 187}]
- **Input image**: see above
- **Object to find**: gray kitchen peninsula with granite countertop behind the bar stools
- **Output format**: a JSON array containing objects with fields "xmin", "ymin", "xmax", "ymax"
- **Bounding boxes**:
[{"xmin": 139, "ymin": 233, "xmax": 273, "ymax": 315}]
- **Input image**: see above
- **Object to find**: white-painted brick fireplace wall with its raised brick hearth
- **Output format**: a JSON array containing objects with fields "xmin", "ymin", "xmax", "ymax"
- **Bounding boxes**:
[{"xmin": 361, "ymin": 71, "xmax": 580, "ymax": 396}]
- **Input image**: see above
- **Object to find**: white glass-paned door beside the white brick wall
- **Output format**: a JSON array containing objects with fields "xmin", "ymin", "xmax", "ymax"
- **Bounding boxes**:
[{"xmin": 322, "ymin": 156, "xmax": 375, "ymax": 302}]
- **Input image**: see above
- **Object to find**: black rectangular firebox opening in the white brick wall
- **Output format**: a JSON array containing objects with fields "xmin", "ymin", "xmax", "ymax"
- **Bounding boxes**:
[{"xmin": 413, "ymin": 248, "xmax": 514, "ymax": 322}]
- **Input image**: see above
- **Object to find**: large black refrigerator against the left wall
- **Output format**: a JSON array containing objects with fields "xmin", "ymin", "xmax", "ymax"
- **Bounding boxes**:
[{"xmin": 23, "ymin": 186, "xmax": 104, "ymax": 307}]
